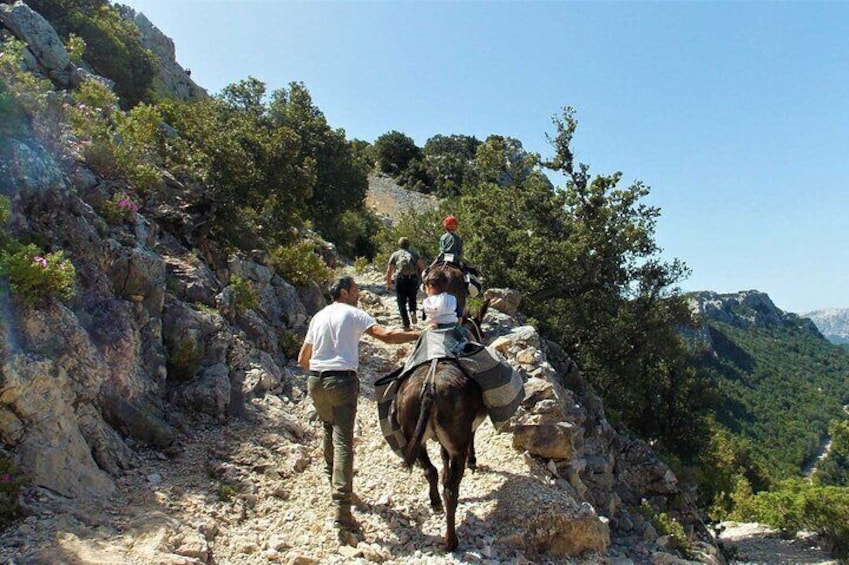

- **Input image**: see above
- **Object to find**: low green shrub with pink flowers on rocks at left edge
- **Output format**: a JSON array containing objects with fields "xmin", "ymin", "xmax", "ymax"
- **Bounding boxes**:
[{"xmin": 0, "ymin": 244, "xmax": 76, "ymax": 306}]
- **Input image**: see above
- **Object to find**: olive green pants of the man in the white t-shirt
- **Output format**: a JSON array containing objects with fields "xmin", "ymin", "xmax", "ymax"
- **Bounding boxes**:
[{"xmin": 307, "ymin": 375, "xmax": 360, "ymax": 508}]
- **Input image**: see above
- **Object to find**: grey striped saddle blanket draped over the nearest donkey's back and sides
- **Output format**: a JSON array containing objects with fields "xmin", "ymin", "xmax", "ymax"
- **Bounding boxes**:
[{"xmin": 374, "ymin": 329, "xmax": 525, "ymax": 455}]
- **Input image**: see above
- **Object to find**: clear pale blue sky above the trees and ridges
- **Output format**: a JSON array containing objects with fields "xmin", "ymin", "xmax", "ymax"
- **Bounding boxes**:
[{"xmin": 122, "ymin": 0, "xmax": 849, "ymax": 313}]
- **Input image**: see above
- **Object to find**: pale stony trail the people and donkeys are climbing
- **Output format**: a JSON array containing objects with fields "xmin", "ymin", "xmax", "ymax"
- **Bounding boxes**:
[{"xmin": 0, "ymin": 272, "xmax": 603, "ymax": 565}]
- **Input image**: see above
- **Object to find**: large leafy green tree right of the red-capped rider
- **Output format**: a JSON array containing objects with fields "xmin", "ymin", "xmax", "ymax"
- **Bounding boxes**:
[{"xmin": 457, "ymin": 109, "xmax": 710, "ymax": 454}]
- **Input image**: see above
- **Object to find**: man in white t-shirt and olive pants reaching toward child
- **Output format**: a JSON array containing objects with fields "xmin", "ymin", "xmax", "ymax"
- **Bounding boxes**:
[{"xmin": 298, "ymin": 277, "xmax": 421, "ymax": 531}]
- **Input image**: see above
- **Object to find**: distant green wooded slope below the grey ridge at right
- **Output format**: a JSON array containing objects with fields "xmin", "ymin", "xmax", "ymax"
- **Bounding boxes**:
[{"xmin": 704, "ymin": 320, "xmax": 849, "ymax": 479}]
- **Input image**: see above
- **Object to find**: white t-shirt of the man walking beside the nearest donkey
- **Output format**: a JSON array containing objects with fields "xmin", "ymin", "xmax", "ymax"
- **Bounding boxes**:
[{"xmin": 304, "ymin": 302, "xmax": 377, "ymax": 371}]
